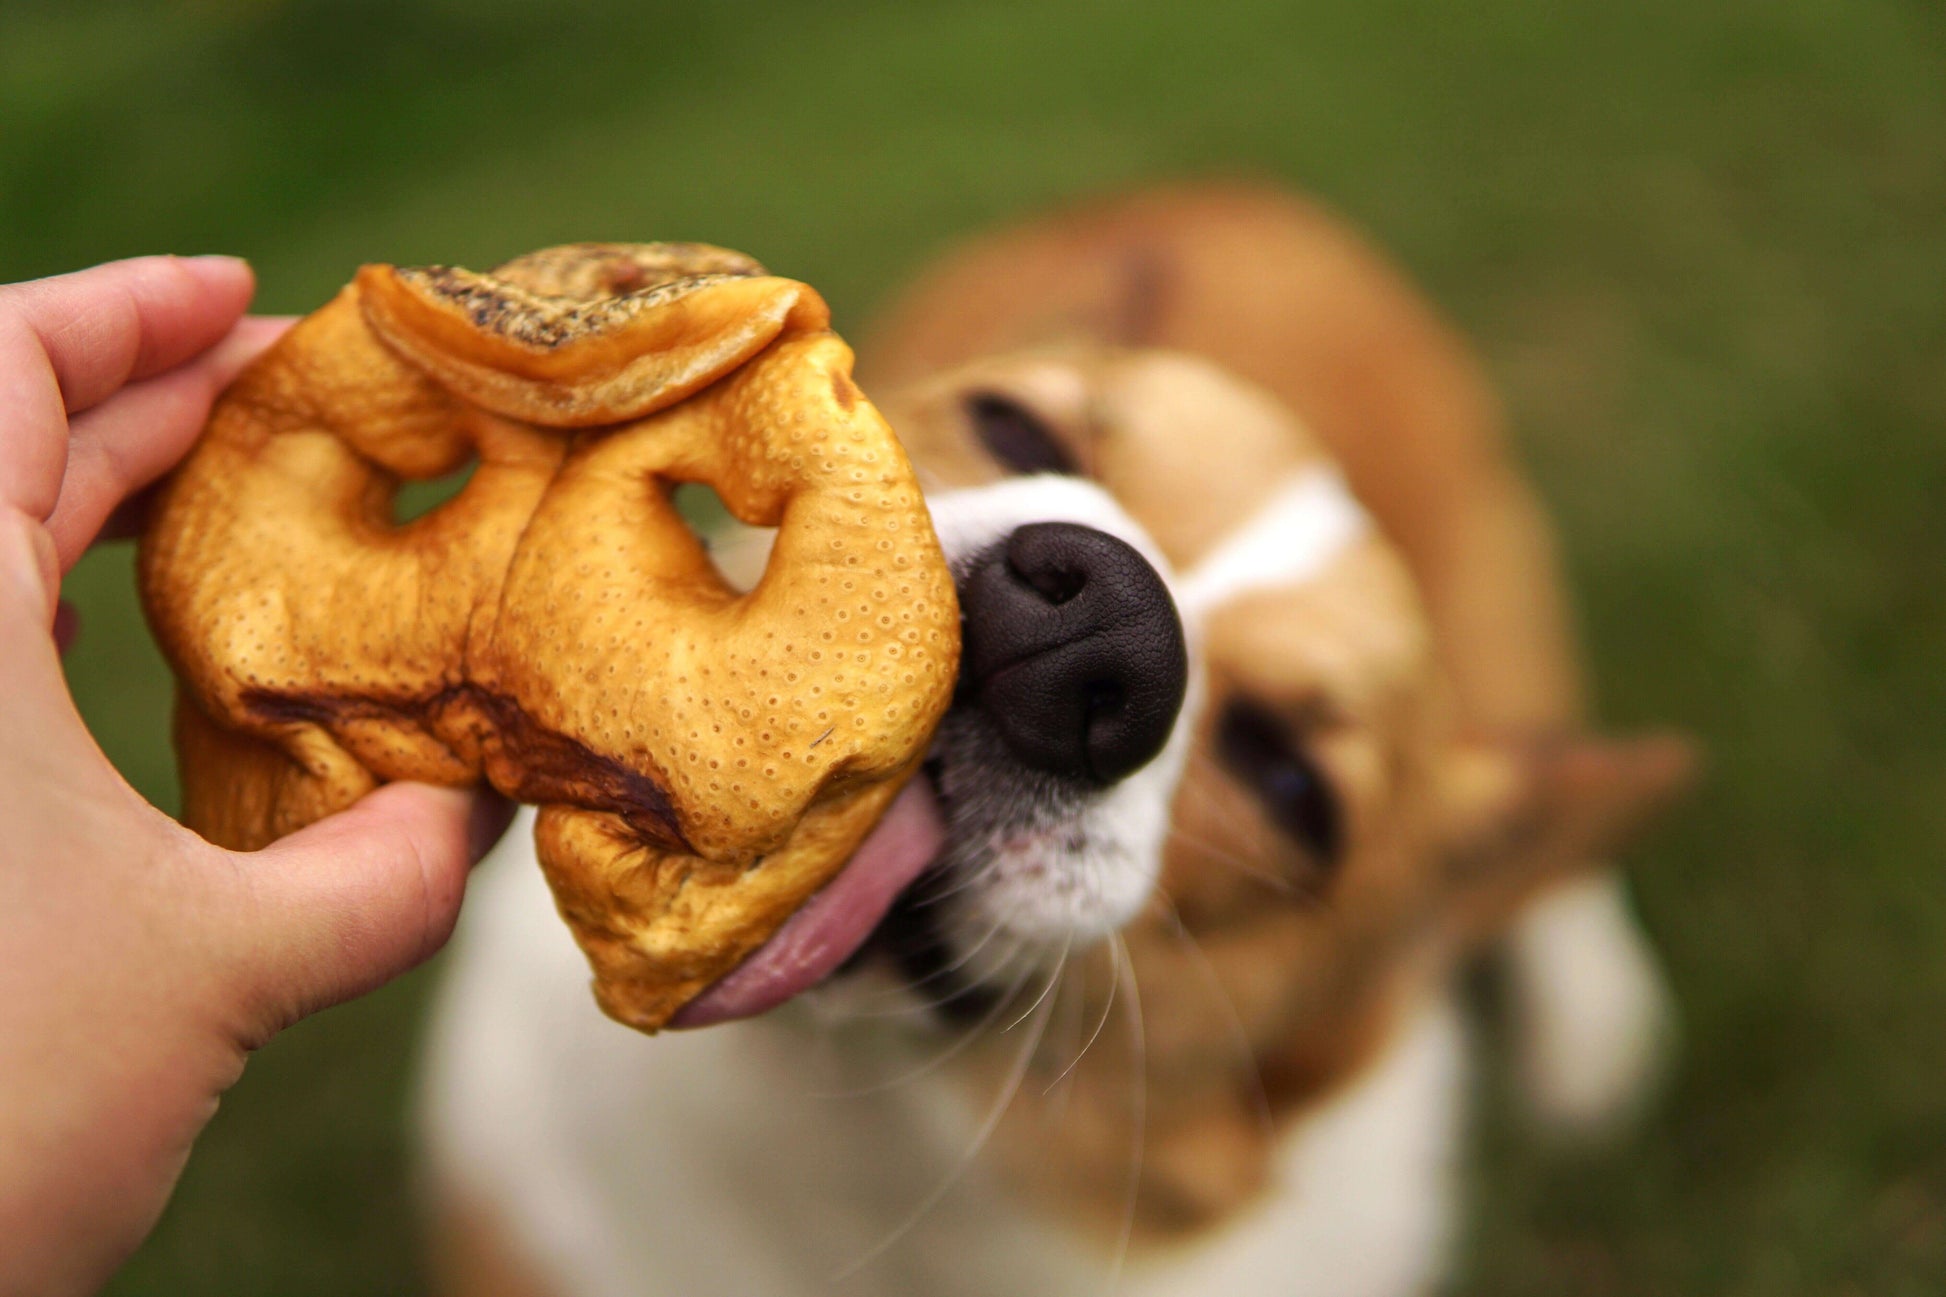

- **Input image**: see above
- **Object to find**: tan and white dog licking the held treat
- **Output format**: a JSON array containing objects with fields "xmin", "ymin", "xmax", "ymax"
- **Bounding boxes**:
[{"xmin": 418, "ymin": 185, "xmax": 1689, "ymax": 1297}]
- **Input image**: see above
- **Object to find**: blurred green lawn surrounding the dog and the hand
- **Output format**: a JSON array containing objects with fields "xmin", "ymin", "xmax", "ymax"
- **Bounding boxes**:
[{"xmin": 0, "ymin": 0, "xmax": 1946, "ymax": 1297}]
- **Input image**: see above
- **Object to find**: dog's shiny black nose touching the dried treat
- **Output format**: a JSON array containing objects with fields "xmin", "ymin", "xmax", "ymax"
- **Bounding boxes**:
[{"xmin": 959, "ymin": 522, "xmax": 1189, "ymax": 785}]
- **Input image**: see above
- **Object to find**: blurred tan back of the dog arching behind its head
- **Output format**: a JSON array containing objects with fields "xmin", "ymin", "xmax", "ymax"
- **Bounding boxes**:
[{"xmin": 860, "ymin": 185, "xmax": 1582, "ymax": 730}]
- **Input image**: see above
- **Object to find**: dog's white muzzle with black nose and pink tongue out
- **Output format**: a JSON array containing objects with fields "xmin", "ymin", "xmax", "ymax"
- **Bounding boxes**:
[{"xmin": 671, "ymin": 477, "xmax": 1187, "ymax": 1026}]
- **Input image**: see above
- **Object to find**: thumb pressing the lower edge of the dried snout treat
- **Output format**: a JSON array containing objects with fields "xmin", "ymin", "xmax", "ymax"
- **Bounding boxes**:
[{"xmin": 226, "ymin": 783, "xmax": 512, "ymax": 1044}]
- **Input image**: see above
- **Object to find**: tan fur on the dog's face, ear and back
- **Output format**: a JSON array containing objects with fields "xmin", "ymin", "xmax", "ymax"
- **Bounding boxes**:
[{"xmin": 430, "ymin": 187, "xmax": 1685, "ymax": 1293}]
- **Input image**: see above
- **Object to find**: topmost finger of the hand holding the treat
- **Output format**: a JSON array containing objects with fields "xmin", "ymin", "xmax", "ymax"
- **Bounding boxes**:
[{"xmin": 0, "ymin": 257, "xmax": 255, "ymax": 518}]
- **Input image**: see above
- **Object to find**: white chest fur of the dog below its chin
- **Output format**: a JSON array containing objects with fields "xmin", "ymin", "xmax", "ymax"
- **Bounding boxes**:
[{"xmin": 422, "ymin": 798, "xmax": 1465, "ymax": 1297}]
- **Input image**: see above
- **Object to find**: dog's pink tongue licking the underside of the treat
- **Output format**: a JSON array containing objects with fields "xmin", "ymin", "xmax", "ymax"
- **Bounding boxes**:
[{"xmin": 669, "ymin": 779, "xmax": 946, "ymax": 1026}]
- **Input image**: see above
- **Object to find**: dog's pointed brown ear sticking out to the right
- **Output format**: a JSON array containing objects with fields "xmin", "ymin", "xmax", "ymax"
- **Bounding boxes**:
[{"xmin": 1440, "ymin": 734, "xmax": 1697, "ymax": 943}]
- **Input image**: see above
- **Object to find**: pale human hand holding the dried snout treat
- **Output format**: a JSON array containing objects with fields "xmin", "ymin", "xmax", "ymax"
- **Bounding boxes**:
[{"xmin": 0, "ymin": 257, "xmax": 506, "ymax": 1293}]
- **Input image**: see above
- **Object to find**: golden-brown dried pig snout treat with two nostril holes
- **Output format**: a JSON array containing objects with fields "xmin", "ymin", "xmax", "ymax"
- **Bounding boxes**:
[{"xmin": 140, "ymin": 243, "xmax": 959, "ymax": 1030}]
